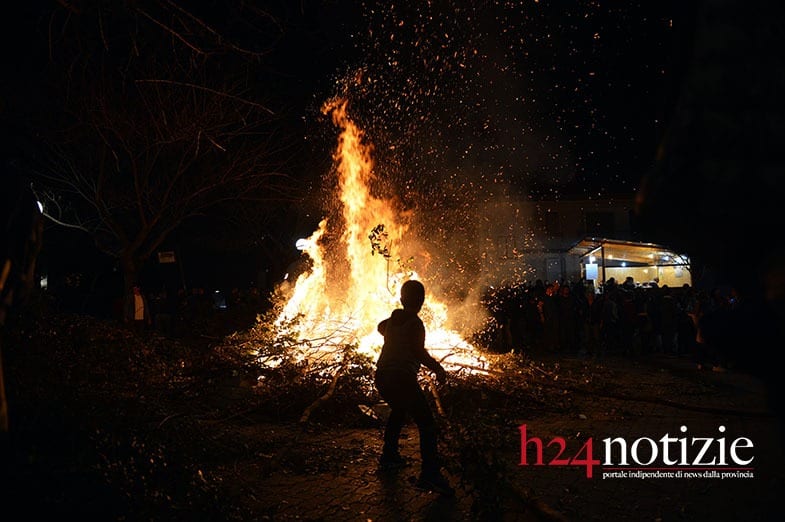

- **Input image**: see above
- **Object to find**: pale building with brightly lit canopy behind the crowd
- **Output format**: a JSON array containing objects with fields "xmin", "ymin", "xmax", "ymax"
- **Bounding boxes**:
[{"xmin": 477, "ymin": 197, "xmax": 690, "ymax": 286}]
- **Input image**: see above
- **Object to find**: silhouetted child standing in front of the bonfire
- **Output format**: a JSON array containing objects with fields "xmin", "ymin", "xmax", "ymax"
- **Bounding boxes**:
[{"xmin": 376, "ymin": 280, "xmax": 453, "ymax": 495}]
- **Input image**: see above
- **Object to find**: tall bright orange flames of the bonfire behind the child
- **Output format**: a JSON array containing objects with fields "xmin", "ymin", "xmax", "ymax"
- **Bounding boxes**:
[{"xmin": 276, "ymin": 99, "xmax": 486, "ymax": 369}]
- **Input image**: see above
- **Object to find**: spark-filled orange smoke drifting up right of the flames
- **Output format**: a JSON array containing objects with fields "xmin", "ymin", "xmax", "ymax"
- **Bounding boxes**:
[{"xmin": 298, "ymin": 0, "xmax": 668, "ymax": 331}]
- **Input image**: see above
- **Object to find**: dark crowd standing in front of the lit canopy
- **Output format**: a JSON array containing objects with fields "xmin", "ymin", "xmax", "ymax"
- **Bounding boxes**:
[{"xmin": 486, "ymin": 277, "xmax": 741, "ymax": 372}]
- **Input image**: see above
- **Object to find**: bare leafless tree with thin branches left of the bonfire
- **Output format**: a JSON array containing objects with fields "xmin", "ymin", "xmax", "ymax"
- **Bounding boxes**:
[{"xmin": 23, "ymin": 0, "xmax": 296, "ymax": 290}]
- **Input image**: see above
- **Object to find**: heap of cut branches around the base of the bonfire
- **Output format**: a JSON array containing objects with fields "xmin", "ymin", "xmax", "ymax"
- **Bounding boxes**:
[{"xmin": 0, "ymin": 304, "xmax": 600, "ymax": 519}]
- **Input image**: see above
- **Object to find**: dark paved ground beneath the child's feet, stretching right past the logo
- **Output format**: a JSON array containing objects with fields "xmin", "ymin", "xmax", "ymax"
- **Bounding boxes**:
[{"xmin": 199, "ymin": 356, "xmax": 785, "ymax": 521}]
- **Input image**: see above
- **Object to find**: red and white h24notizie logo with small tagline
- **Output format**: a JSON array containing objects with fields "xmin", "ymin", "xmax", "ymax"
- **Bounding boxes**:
[{"xmin": 518, "ymin": 424, "xmax": 755, "ymax": 478}]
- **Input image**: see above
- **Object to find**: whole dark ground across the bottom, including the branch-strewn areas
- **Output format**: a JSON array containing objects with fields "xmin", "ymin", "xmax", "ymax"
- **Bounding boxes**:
[{"xmin": 0, "ymin": 306, "xmax": 785, "ymax": 521}]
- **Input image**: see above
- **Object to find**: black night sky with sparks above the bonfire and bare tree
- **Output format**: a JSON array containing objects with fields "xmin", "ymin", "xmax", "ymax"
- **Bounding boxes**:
[{"xmin": 0, "ymin": 0, "xmax": 689, "ymax": 290}]
